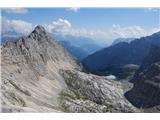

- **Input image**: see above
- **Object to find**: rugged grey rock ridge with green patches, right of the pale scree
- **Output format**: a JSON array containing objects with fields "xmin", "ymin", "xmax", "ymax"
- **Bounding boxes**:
[{"xmin": 61, "ymin": 70, "xmax": 139, "ymax": 112}]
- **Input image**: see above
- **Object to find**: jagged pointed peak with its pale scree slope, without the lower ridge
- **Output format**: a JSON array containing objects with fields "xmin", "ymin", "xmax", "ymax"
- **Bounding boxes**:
[{"xmin": 1, "ymin": 26, "xmax": 80, "ymax": 112}]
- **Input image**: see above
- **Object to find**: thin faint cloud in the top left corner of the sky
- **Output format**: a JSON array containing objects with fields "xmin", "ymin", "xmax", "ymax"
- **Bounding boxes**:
[{"xmin": 2, "ymin": 8, "xmax": 28, "ymax": 14}]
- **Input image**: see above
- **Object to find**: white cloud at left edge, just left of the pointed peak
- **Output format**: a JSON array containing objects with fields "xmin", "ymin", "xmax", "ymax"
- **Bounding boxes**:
[{"xmin": 1, "ymin": 18, "xmax": 33, "ymax": 34}]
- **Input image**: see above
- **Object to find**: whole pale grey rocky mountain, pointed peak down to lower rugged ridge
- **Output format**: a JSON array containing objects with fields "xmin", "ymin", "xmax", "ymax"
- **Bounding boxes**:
[{"xmin": 1, "ymin": 26, "xmax": 139, "ymax": 112}]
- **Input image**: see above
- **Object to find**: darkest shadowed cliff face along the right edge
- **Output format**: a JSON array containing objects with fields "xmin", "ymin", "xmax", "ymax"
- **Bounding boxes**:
[{"xmin": 126, "ymin": 46, "xmax": 160, "ymax": 111}]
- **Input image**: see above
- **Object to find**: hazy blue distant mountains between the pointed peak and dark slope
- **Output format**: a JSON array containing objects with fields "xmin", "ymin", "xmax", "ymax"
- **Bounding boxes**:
[{"xmin": 52, "ymin": 34, "xmax": 106, "ymax": 61}]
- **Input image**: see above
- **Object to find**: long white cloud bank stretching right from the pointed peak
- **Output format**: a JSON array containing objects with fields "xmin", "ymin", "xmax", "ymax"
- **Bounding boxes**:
[{"xmin": 45, "ymin": 19, "xmax": 159, "ymax": 44}]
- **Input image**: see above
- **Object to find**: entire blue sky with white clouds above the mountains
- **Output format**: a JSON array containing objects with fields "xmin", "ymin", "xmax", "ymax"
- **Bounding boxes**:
[{"xmin": 1, "ymin": 8, "xmax": 160, "ymax": 43}]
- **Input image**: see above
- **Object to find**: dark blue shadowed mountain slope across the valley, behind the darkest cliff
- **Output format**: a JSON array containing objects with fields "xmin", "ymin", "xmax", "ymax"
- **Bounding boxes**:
[{"xmin": 82, "ymin": 32, "xmax": 160, "ymax": 71}]
